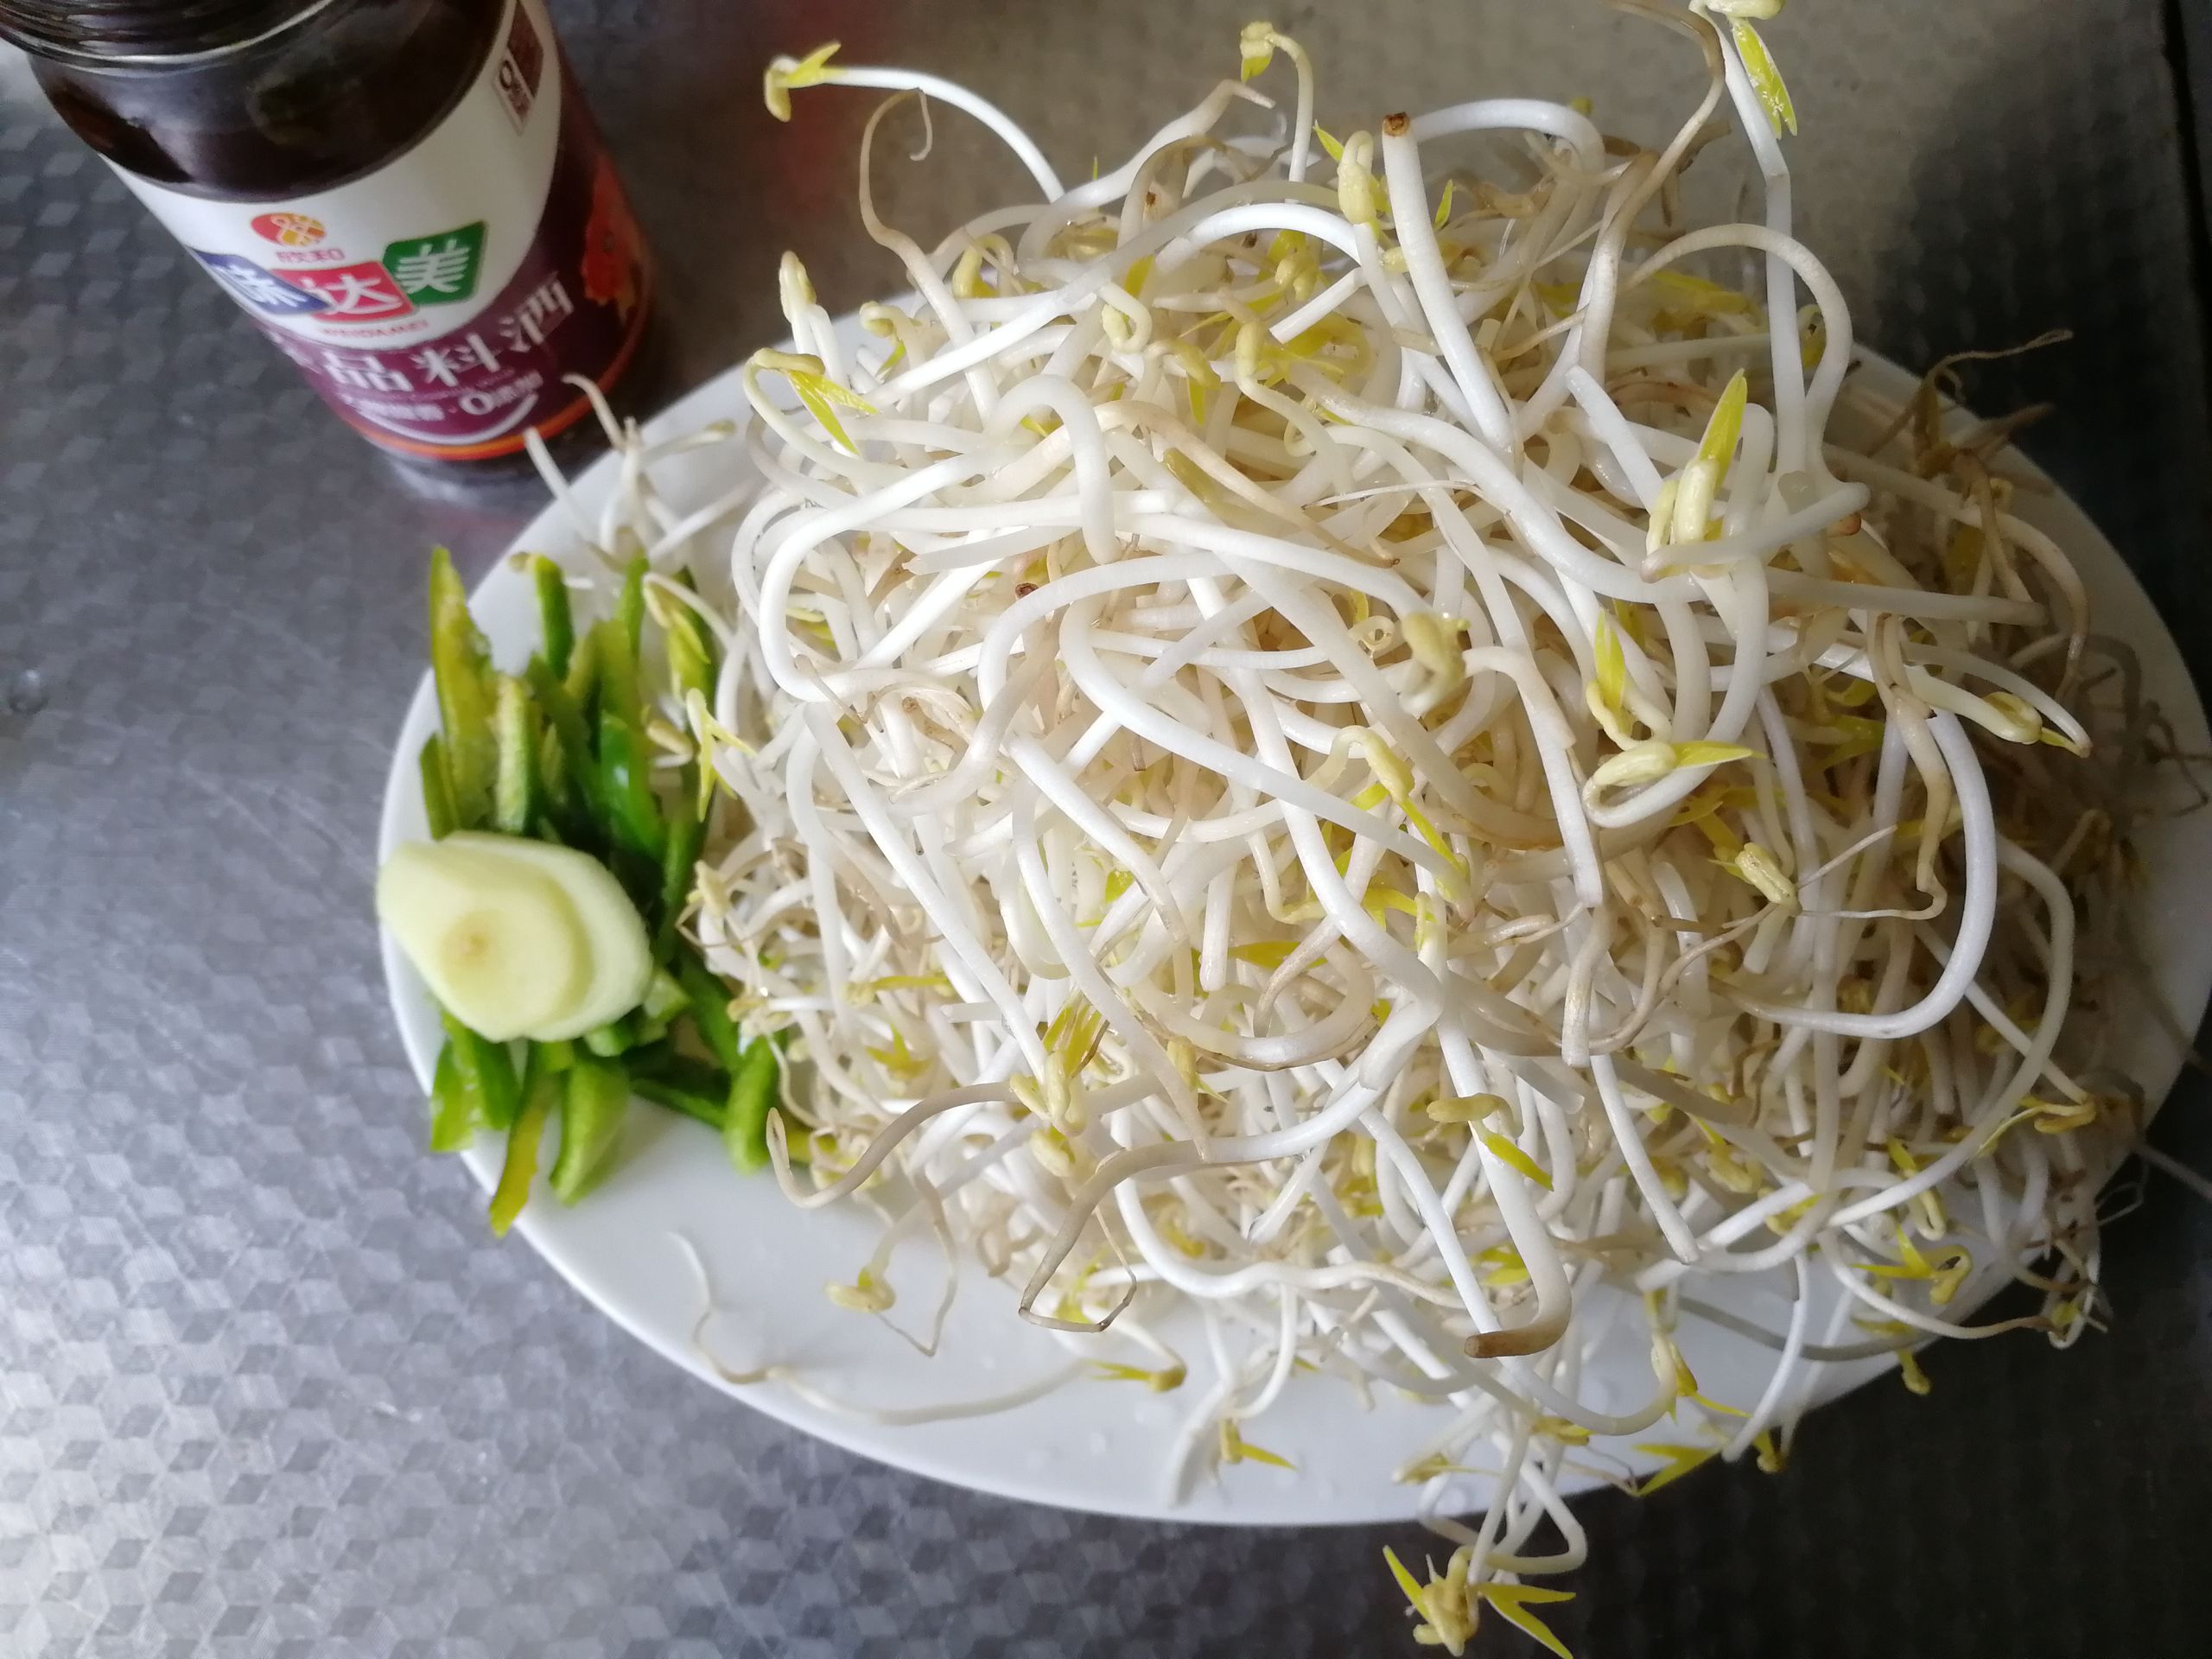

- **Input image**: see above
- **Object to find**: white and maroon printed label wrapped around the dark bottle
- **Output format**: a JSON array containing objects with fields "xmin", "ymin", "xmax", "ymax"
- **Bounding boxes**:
[{"xmin": 118, "ymin": 0, "xmax": 652, "ymax": 460}]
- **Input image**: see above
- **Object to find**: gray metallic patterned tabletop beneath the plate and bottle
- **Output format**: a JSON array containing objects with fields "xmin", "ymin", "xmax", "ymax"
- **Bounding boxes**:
[{"xmin": 0, "ymin": 0, "xmax": 2212, "ymax": 1659}]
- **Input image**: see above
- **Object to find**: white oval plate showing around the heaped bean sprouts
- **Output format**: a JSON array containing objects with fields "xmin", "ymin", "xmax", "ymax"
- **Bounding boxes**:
[{"xmin": 378, "ymin": 319, "xmax": 2212, "ymax": 1526}]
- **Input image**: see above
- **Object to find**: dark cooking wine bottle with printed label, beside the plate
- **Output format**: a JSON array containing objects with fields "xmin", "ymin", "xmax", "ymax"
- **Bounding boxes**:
[{"xmin": 0, "ymin": 0, "xmax": 652, "ymax": 474}]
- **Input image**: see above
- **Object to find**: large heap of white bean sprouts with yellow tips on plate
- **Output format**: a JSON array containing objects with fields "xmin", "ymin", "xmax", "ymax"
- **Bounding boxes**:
[{"xmin": 522, "ymin": 0, "xmax": 2194, "ymax": 1652}]
